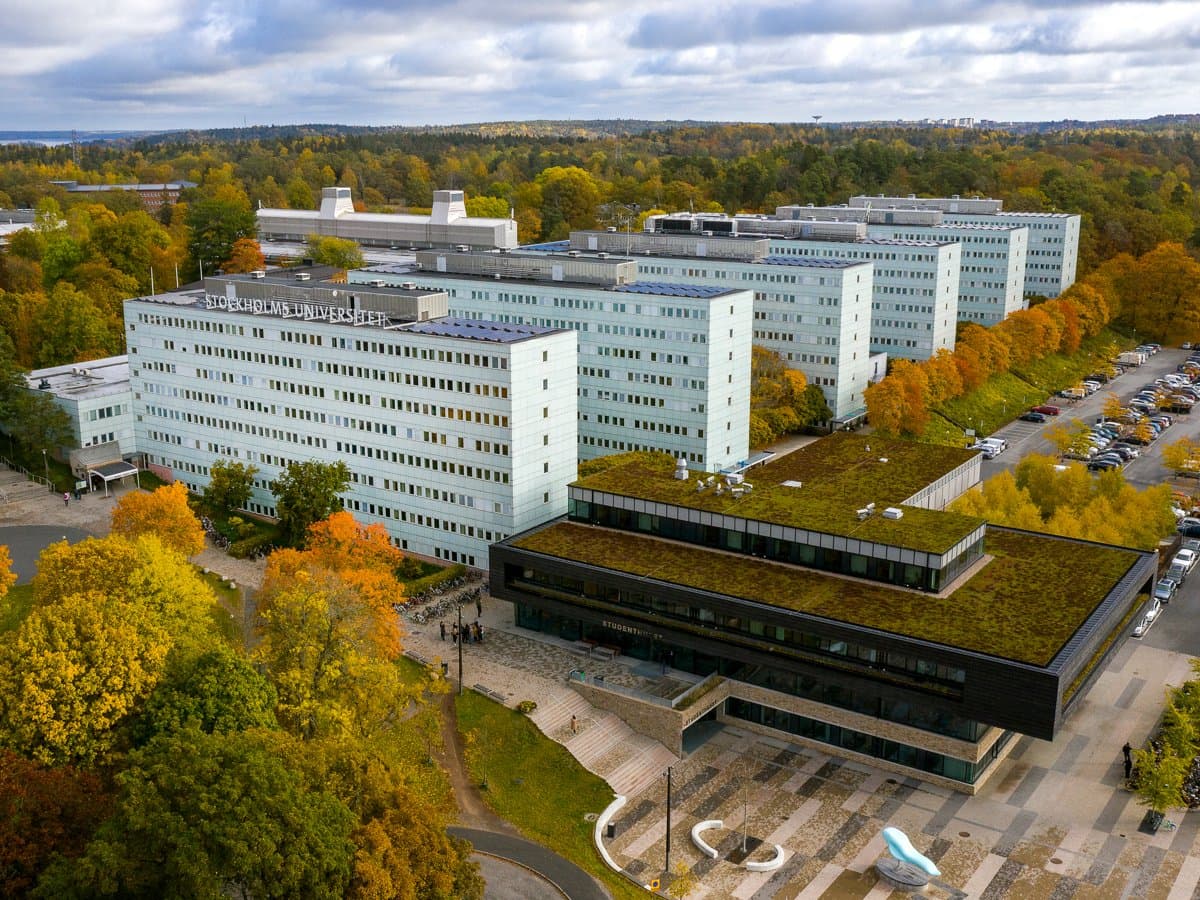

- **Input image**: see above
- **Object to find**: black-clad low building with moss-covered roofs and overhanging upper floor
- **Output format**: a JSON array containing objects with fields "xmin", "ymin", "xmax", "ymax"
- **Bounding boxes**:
[{"xmin": 490, "ymin": 433, "xmax": 1157, "ymax": 792}]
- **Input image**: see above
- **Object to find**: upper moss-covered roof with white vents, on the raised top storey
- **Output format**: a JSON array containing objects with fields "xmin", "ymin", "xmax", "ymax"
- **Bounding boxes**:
[{"xmin": 575, "ymin": 432, "xmax": 984, "ymax": 553}]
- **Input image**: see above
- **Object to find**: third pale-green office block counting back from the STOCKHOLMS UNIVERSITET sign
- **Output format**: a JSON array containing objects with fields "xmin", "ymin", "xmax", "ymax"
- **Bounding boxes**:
[{"xmin": 563, "ymin": 229, "xmax": 873, "ymax": 418}]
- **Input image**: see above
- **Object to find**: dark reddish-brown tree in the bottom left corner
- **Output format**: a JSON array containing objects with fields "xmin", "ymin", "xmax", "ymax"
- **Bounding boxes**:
[{"xmin": 0, "ymin": 750, "xmax": 109, "ymax": 898}]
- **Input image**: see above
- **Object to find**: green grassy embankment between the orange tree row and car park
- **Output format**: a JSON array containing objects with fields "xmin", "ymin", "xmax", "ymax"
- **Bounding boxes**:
[{"xmin": 919, "ymin": 330, "xmax": 1130, "ymax": 446}]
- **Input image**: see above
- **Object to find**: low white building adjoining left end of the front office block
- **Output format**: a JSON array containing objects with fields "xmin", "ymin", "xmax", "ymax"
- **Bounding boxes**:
[{"xmin": 25, "ymin": 356, "xmax": 137, "ymax": 457}]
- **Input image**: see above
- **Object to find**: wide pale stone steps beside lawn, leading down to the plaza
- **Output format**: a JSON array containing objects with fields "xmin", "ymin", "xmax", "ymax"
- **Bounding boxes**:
[{"xmin": 530, "ymin": 686, "xmax": 679, "ymax": 797}]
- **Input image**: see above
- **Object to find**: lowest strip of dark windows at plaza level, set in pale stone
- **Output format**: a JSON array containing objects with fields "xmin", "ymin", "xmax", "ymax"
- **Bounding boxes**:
[{"xmin": 725, "ymin": 697, "xmax": 1013, "ymax": 785}]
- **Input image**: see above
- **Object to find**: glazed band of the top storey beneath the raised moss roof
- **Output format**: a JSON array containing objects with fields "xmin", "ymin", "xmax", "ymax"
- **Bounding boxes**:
[{"xmin": 568, "ymin": 497, "xmax": 983, "ymax": 592}]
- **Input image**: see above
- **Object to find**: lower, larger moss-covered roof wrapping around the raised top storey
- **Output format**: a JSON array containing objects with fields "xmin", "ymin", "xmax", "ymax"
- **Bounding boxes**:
[{"xmin": 514, "ymin": 522, "xmax": 1139, "ymax": 666}]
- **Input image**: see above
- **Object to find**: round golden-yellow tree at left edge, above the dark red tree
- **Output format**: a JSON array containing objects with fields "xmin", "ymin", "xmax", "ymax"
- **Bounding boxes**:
[{"xmin": 0, "ymin": 592, "xmax": 172, "ymax": 766}]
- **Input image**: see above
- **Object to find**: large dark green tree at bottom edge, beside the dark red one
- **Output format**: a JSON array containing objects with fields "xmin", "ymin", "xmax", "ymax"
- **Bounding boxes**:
[{"xmin": 35, "ymin": 728, "xmax": 354, "ymax": 900}]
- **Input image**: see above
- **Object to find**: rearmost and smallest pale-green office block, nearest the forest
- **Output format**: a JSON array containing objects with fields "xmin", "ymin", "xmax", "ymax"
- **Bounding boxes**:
[{"xmin": 850, "ymin": 194, "xmax": 1080, "ymax": 296}]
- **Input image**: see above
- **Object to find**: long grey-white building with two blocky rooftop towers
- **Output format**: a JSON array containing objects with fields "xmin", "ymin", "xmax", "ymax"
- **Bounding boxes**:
[{"xmin": 257, "ymin": 187, "xmax": 517, "ymax": 250}]
